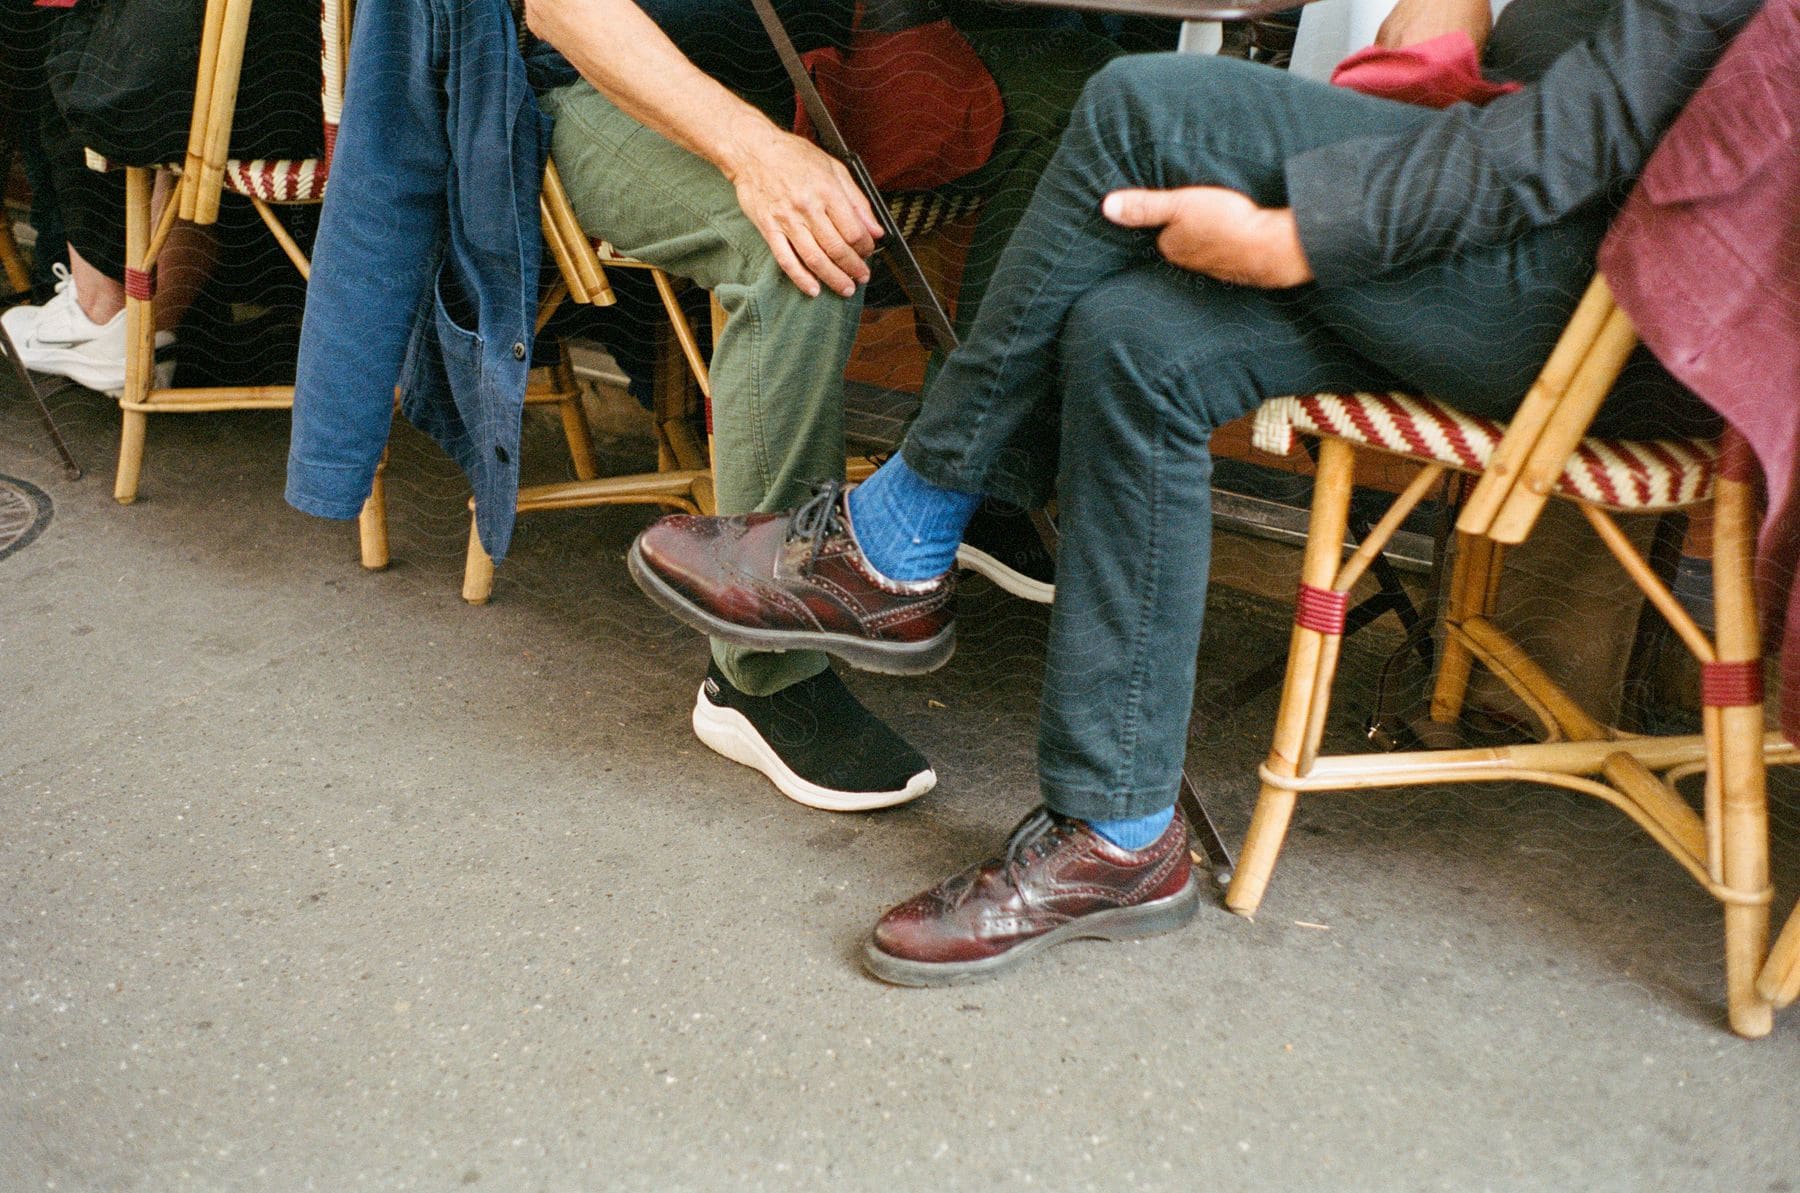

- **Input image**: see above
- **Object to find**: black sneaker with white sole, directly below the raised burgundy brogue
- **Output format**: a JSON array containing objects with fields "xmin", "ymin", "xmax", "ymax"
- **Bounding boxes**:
[{"xmin": 693, "ymin": 662, "xmax": 938, "ymax": 812}]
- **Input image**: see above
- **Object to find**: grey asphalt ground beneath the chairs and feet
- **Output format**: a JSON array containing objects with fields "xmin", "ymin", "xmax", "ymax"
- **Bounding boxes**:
[{"xmin": 0, "ymin": 379, "xmax": 1800, "ymax": 1193}]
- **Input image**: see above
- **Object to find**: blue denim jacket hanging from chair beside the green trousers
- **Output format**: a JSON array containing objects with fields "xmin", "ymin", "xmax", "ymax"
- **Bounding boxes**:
[{"xmin": 286, "ymin": 0, "xmax": 549, "ymax": 561}]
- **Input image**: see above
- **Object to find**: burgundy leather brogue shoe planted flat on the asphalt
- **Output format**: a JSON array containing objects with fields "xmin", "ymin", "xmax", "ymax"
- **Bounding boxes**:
[{"xmin": 862, "ymin": 808, "xmax": 1201, "ymax": 986}]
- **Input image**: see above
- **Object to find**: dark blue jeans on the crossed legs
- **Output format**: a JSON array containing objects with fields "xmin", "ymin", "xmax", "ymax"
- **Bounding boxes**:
[{"xmin": 904, "ymin": 54, "xmax": 1677, "ymax": 819}]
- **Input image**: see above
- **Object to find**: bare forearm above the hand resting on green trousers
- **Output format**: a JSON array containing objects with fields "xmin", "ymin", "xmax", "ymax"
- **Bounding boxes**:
[{"xmin": 526, "ymin": 0, "xmax": 779, "ymax": 178}]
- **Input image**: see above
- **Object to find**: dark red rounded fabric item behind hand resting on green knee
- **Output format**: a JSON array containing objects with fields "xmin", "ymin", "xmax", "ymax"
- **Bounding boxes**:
[{"xmin": 794, "ymin": 20, "xmax": 1006, "ymax": 191}]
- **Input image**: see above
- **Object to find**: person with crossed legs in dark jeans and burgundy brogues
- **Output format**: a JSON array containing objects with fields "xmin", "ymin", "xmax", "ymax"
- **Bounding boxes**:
[{"xmin": 632, "ymin": 0, "xmax": 1759, "ymax": 984}]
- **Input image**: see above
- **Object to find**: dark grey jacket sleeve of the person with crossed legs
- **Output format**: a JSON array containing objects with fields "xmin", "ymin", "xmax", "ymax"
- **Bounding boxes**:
[{"xmin": 1287, "ymin": 0, "xmax": 1762, "ymax": 284}]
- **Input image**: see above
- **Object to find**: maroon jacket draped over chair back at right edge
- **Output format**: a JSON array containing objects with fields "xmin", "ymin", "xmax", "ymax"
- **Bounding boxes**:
[{"xmin": 1600, "ymin": 0, "xmax": 1800, "ymax": 743}]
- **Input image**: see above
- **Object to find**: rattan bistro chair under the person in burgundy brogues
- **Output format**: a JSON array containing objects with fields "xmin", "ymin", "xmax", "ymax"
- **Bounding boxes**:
[{"xmin": 1226, "ymin": 277, "xmax": 1800, "ymax": 1036}]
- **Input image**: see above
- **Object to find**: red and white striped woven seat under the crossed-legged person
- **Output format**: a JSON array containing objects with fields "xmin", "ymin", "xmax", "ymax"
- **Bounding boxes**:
[{"xmin": 1251, "ymin": 394, "xmax": 1719, "ymax": 511}]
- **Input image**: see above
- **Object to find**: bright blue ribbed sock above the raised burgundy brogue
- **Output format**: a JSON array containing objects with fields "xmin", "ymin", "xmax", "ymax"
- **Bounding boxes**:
[{"xmin": 850, "ymin": 453, "xmax": 981, "ymax": 579}]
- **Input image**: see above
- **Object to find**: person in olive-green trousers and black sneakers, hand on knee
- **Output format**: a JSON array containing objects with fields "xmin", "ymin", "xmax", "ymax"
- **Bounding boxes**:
[{"xmin": 524, "ymin": 0, "xmax": 1116, "ymax": 812}]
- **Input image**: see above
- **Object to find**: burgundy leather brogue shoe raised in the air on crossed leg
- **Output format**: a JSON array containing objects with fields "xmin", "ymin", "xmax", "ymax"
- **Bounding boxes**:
[{"xmin": 630, "ymin": 480, "xmax": 956, "ymax": 675}]
